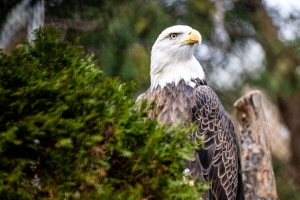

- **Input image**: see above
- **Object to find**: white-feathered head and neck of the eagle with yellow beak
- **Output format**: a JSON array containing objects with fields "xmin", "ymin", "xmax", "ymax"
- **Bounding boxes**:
[{"xmin": 150, "ymin": 25, "xmax": 205, "ymax": 89}]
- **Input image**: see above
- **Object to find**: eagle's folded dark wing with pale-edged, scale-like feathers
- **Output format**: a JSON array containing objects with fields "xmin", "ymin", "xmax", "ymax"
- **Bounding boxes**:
[{"xmin": 190, "ymin": 85, "xmax": 244, "ymax": 200}]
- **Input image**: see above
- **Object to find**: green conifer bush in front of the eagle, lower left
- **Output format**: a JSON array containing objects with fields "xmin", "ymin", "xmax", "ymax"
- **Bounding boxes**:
[{"xmin": 0, "ymin": 26, "xmax": 205, "ymax": 199}]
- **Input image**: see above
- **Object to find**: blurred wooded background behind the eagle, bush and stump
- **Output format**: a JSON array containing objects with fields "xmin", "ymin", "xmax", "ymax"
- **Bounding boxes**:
[{"xmin": 0, "ymin": 0, "xmax": 300, "ymax": 199}]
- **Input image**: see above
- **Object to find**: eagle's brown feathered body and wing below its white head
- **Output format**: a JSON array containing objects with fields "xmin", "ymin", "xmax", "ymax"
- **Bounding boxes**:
[{"xmin": 138, "ymin": 79, "xmax": 244, "ymax": 200}]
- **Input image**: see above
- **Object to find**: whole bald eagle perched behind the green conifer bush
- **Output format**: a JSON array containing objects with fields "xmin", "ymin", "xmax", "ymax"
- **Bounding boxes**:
[{"xmin": 138, "ymin": 25, "xmax": 244, "ymax": 200}]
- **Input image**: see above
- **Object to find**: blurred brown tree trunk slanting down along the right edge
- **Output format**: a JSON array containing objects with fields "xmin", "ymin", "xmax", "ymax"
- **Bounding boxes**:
[{"xmin": 235, "ymin": 0, "xmax": 300, "ymax": 185}]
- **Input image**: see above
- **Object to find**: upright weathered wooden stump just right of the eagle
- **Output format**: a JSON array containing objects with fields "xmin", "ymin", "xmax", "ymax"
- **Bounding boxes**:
[{"xmin": 234, "ymin": 90, "xmax": 278, "ymax": 200}]
